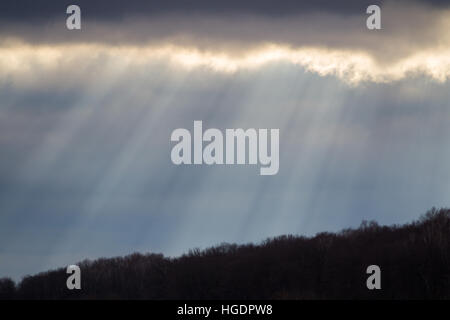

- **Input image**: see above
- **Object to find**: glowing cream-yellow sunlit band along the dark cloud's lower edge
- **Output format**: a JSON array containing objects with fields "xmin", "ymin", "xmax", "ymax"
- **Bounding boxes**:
[{"xmin": 0, "ymin": 45, "xmax": 450, "ymax": 86}]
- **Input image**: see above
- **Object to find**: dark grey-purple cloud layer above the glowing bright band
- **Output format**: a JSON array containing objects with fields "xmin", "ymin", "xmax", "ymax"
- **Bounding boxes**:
[{"xmin": 0, "ymin": 0, "xmax": 450, "ymax": 67}]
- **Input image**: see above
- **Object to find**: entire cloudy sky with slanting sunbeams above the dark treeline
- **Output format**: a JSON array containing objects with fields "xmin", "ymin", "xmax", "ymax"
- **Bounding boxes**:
[{"xmin": 0, "ymin": 0, "xmax": 450, "ymax": 280}]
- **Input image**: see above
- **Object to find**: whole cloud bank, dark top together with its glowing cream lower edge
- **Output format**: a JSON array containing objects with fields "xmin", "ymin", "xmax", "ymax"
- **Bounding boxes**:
[{"xmin": 0, "ymin": 1, "xmax": 450, "ymax": 85}]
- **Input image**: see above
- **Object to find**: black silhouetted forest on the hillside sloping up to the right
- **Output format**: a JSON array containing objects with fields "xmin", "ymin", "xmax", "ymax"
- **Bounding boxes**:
[{"xmin": 0, "ymin": 209, "xmax": 450, "ymax": 299}]
